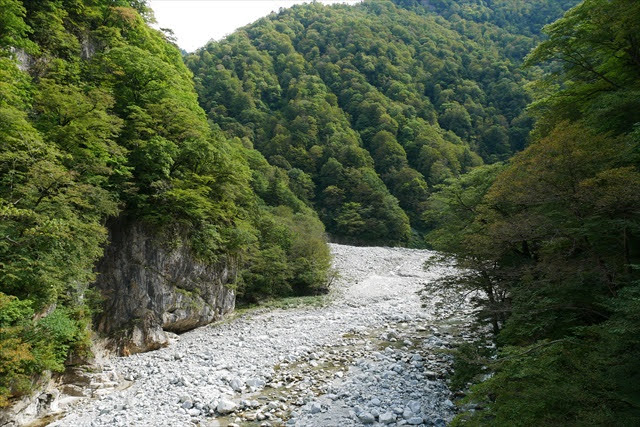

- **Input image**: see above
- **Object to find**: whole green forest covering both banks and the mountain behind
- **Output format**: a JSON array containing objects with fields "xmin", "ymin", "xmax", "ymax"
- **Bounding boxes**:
[{"xmin": 0, "ymin": 0, "xmax": 640, "ymax": 426}]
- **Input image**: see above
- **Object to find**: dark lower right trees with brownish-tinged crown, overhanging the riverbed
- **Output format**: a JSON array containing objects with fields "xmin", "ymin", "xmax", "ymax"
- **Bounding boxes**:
[{"xmin": 440, "ymin": 123, "xmax": 640, "ymax": 425}]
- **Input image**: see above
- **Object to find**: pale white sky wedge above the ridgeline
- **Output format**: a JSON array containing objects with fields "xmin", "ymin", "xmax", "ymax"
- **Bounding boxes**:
[{"xmin": 148, "ymin": 0, "xmax": 360, "ymax": 52}]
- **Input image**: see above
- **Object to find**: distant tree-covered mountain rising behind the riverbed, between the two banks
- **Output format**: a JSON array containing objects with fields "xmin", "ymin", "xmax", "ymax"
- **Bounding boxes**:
[{"xmin": 186, "ymin": 1, "xmax": 575, "ymax": 244}]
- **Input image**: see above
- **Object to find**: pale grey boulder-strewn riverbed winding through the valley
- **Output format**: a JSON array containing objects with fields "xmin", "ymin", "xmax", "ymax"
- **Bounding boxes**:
[{"xmin": 48, "ymin": 245, "xmax": 471, "ymax": 427}]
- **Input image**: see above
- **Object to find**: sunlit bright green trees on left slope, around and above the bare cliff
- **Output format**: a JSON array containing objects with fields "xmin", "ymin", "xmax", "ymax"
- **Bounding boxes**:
[{"xmin": 0, "ymin": 0, "xmax": 329, "ymax": 406}]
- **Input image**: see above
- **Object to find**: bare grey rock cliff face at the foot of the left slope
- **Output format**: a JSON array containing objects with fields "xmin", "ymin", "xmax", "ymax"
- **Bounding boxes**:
[{"xmin": 95, "ymin": 219, "xmax": 235, "ymax": 355}]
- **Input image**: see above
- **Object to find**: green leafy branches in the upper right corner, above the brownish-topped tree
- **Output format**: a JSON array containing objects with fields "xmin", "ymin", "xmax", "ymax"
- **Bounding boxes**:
[{"xmin": 527, "ymin": 0, "xmax": 640, "ymax": 134}]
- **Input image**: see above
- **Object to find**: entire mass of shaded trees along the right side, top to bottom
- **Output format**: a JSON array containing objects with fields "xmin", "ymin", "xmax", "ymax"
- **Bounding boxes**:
[{"xmin": 426, "ymin": 0, "xmax": 640, "ymax": 426}]
